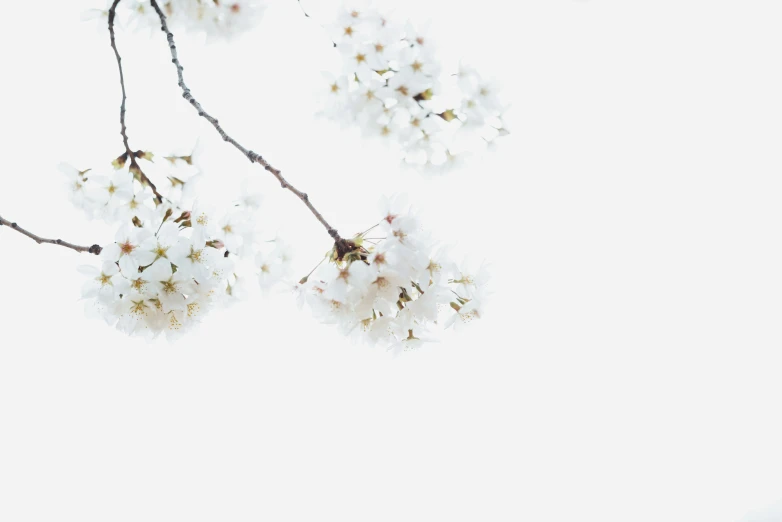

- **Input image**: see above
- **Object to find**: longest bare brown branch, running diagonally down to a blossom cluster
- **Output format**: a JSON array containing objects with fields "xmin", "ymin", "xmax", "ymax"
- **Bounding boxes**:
[{"xmin": 151, "ymin": 0, "xmax": 352, "ymax": 250}]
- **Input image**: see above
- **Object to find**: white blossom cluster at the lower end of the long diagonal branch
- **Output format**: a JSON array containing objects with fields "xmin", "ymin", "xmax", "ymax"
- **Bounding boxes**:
[{"xmin": 297, "ymin": 197, "xmax": 488, "ymax": 351}]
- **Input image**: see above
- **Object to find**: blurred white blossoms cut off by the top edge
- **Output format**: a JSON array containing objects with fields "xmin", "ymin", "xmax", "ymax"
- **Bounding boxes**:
[{"xmin": 85, "ymin": 0, "xmax": 266, "ymax": 38}]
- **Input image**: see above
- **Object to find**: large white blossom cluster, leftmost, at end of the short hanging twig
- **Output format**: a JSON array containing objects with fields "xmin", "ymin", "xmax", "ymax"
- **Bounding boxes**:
[{"xmin": 66, "ymin": 153, "xmax": 290, "ymax": 338}]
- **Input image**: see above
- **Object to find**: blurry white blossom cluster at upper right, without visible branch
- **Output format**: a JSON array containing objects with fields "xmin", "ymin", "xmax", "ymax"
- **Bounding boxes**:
[{"xmin": 321, "ymin": 6, "xmax": 508, "ymax": 172}]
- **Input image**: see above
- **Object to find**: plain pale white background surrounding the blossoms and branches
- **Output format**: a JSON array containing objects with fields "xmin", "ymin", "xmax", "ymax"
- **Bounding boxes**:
[{"xmin": 0, "ymin": 0, "xmax": 782, "ymax": 522}]
